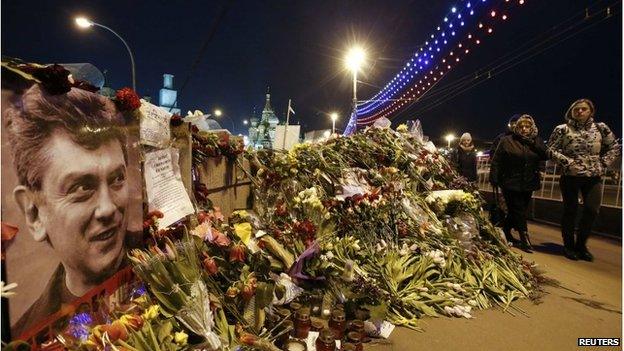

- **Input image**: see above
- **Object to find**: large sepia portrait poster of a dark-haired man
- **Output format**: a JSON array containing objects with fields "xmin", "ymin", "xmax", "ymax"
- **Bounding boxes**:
[{"xmin": 1, "ymin": 67, "xmax": 142, "ymax": 338}]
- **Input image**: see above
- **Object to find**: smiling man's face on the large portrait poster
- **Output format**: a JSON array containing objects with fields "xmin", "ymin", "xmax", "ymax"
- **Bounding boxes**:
[{"xmin": 25, "ymin": 132, "xmax": 129, "ymax": 280}]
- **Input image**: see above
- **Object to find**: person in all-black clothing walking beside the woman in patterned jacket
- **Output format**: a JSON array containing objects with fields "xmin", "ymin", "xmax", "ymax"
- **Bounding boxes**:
[{"xmin": 490, "ymin": 114, "xmax": 546, "ymax": 253}]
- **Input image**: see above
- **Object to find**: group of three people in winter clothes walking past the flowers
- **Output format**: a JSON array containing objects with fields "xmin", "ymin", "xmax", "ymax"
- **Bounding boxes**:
[{"xmin": 451, "ymin": 99, "xmax": 620, "ymax": 261}]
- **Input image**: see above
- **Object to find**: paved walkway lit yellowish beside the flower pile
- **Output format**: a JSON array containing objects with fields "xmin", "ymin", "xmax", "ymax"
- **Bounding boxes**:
[{"xmin": 366, "ymin": 224, "xmax": 622, "ymax": 351}]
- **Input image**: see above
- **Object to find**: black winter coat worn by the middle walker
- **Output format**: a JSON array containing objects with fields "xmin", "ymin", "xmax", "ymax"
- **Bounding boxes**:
[{"xmin": 490, "ymin": 134, "xmax": 546, "ymax": 191}]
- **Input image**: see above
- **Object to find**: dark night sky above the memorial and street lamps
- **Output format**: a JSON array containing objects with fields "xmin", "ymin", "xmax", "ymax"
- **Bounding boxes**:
[{"xmin": 2, "ymin": 0, "xmax": 622, "ymax": 139}]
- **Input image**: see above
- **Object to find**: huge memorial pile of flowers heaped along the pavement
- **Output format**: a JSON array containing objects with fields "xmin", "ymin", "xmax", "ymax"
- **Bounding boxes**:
[{"xmin": 70, "ymin": 127, "xmax": 539, "ymax": 350}]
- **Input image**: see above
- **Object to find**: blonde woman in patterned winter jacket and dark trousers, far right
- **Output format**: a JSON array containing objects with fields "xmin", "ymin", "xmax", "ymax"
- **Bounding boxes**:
[{"xmin": 548, "ymin": 99, "xmax": 620, "ymax": 261}]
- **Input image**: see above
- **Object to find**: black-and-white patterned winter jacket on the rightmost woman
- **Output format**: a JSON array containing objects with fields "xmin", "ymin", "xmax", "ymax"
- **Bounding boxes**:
[{"xmin": 548, "ymin": 116, "xmax": 620, "ymax": 177}]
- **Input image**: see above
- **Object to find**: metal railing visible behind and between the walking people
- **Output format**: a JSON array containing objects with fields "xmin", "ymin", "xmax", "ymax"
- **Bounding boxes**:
[{"xmin": 477, "ymin": 156, "xmax": 622, "ymax": 208}]
